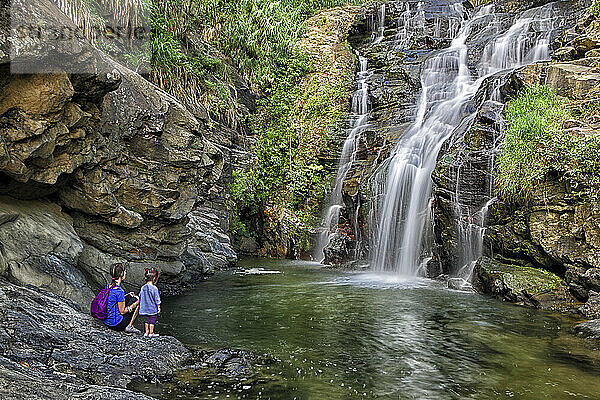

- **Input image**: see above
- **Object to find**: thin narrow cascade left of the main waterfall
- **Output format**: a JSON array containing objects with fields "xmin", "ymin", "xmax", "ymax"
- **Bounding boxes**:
[{"xmin": 315, "ymin": 54, "xmax": 371, "ymax": 261}]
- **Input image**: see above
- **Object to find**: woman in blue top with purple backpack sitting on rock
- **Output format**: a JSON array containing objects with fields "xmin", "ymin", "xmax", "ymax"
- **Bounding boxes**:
[{"xmin": 104, "ymin": 263, "xmax": 140, "ymax": 333}]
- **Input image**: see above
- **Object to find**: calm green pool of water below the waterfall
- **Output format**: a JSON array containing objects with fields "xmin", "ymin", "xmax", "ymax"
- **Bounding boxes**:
[{"xmin": 148, "ymin": 259, "xmax": 600, "ymax": 399}]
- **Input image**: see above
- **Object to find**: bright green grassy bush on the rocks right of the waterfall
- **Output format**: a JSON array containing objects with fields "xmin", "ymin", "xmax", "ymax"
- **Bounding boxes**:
[{"xmin": 497, "ymin": 85, "xmax": 600, "ymax": 199}]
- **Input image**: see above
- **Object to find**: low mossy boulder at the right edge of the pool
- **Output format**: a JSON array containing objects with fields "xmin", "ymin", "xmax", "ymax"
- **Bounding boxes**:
[{"xmin": 473, "ymin": 257, "xmax": 578, "ymax": 311}]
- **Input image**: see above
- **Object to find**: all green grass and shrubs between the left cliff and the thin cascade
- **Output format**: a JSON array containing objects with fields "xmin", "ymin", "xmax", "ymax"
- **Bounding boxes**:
[{"xmin": 61, "ymin": 0, "xmax": 362, "ymax": 252}]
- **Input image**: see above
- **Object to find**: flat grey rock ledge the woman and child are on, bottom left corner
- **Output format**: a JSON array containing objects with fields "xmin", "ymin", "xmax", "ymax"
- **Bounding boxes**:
[{"xmin": 0, "ymin": 279, "xmax": 191, "ymax": 400}]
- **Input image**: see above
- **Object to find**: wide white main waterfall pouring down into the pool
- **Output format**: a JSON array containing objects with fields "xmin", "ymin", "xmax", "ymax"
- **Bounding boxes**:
[{"xmin": 371, "ymin": 4, "xmax": 564, "ymax": 275}]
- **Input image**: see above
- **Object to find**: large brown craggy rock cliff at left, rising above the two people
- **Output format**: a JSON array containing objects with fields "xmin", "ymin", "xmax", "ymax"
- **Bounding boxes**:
[{"xmin": 0, "ymin": 0, "xmax": 239, "ymax": 304}]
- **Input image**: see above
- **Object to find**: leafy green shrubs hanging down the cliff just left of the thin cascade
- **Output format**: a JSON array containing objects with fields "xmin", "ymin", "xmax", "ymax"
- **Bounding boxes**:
[{"xmin": 226, "ymin": 0, "xmax": 357, "ymax": 249}]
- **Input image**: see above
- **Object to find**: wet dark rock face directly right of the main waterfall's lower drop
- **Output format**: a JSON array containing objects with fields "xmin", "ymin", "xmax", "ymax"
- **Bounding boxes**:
[{"xmin": 432, "ymin": 92, "xmax": 508, "ymax": 273}]
